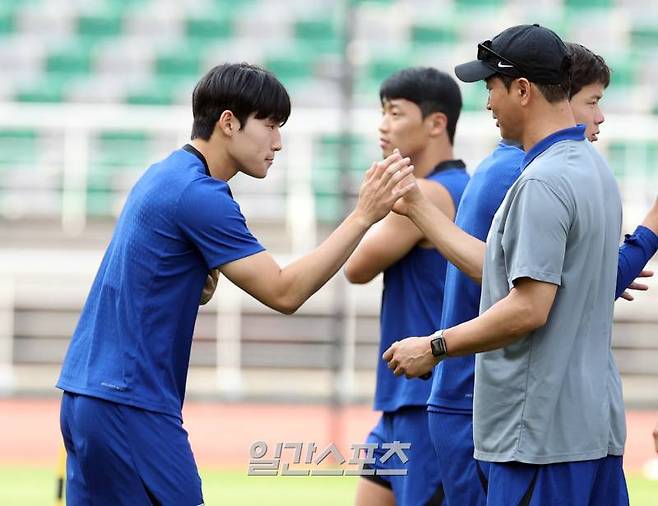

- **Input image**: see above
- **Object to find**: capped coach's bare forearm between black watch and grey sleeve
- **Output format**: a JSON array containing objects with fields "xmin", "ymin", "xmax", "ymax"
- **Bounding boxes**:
[{"xmin": 444, "ymin": 293, "xmax": 545, "ymax": 356}]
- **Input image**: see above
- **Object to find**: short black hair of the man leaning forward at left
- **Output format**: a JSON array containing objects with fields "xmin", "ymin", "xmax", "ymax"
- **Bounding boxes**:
[{"xmin": 192, "ymin": 63, "xmax": 290, "ymax": 141}]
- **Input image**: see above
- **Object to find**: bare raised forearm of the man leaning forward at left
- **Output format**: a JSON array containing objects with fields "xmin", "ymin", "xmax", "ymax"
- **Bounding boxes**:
[{"xmin": 281, "ymin": 213, "xmax": 369, "ymax": 311}]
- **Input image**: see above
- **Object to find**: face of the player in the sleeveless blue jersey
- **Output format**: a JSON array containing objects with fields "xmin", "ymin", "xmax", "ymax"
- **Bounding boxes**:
[{"xmin": 379, "ymin": 98, "xmax": 429, "ymax": 158}]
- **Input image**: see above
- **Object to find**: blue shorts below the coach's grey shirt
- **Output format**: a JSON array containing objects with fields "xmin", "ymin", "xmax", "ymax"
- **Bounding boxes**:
[{"xmin": 487, "ymin": 455, "xmax": 628, "ymax": 506}]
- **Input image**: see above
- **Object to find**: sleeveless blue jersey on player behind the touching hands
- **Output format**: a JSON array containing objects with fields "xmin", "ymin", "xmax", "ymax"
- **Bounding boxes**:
[{"xmin": 375, "ymin": 160, "xmax": 469, "ymax": 412}]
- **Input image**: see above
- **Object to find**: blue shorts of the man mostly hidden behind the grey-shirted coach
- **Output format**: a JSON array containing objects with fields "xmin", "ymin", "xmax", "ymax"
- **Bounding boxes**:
[{"xmin": 427, "ymin": 411, "xmax": 489, "ymax": 506}]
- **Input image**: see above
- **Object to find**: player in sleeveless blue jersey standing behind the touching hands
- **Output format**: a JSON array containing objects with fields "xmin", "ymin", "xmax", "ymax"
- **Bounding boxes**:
[{"xmin": 345, "ymin": 67, "xmax": 469, "ymax": 506}]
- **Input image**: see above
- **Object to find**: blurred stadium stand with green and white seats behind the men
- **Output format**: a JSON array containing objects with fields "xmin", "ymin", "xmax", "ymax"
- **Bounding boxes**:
[{"xmin": 0, "ymin": 0, "xmax": 658, "ymax": 403}]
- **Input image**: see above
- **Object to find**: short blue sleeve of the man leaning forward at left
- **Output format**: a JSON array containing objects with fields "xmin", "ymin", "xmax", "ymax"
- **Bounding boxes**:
[{"xmin": 177, "ymin": 178, "xmax": 264, "ymax": 269}]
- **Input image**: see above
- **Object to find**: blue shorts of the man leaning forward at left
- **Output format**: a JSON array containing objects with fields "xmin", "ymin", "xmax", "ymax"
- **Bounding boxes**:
[{"xmin": 60, "ymin": 392, "xmax": 203, "ymax": 506}]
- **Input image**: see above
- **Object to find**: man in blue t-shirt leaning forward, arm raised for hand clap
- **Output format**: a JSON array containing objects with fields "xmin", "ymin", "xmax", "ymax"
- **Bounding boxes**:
[{"xmin": 57, "ymin": 64, "xmax": 412, "ymax": 506}]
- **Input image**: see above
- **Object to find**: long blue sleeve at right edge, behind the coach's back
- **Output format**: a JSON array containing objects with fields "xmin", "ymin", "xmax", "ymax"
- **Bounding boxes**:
[{"xmin": 615, "ymin": 225, "xmax": 658, "ymax": 299}]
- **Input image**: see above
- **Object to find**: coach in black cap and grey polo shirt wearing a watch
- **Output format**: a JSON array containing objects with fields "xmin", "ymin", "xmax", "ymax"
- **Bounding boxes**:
[{"xmin": 383, "ymin": 25, "xmax": 628, "ymax": 506}]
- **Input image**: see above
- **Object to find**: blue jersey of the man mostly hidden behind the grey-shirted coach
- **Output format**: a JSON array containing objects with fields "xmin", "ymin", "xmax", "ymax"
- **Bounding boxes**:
[{"xmin": 426, "ymin": 141, "xmax": 525, "ymax": 411}]
